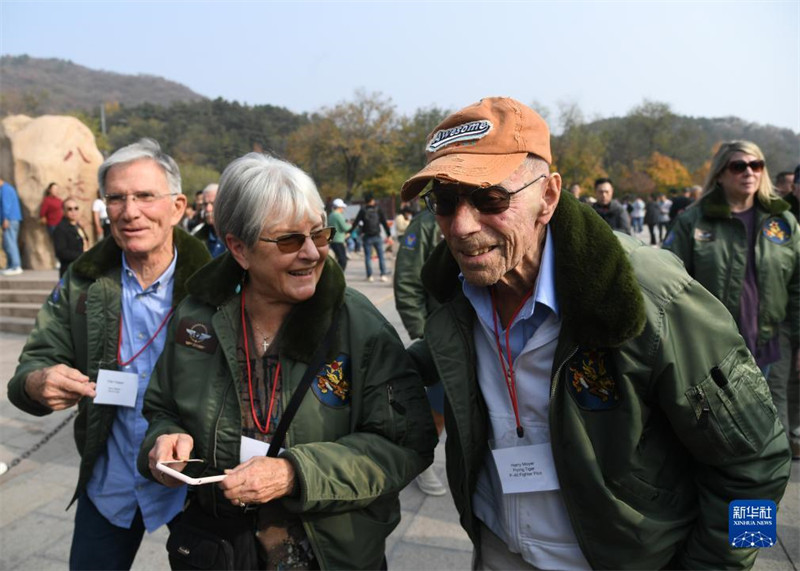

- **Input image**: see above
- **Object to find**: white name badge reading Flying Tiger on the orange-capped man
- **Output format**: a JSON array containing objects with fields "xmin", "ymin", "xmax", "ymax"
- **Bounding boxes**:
[{"xmin": 492, "ymin": 442, "xmax": 560, "ymax": 494}]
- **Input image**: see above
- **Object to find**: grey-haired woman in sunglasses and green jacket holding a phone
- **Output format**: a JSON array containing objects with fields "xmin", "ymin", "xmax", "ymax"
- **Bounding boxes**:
[{"xmin": 139, "ymin": 153, "xmax": 436, "ymax": 569}]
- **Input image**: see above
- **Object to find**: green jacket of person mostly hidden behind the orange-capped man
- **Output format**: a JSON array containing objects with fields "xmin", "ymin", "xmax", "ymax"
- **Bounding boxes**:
[{"xmin": 394, "ymin": 209, "xmax": 442, "ymax": 339}]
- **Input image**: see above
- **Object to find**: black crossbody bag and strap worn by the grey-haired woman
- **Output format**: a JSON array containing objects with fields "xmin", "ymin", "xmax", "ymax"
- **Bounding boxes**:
[{"xmin": 167, "ymin": 310, "xmax": 340, "ymax": 571}]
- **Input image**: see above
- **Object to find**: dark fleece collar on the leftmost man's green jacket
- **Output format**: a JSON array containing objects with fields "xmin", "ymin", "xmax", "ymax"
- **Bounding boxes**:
[{"xmin": 70, "ymin": 227, "xmax": 211, "ymax": 307}]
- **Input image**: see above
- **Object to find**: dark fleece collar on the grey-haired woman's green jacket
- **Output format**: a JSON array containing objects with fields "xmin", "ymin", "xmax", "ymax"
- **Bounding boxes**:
[{"xmin": 187, "ymin": 252, "xmax": 345, "ymax": 363}]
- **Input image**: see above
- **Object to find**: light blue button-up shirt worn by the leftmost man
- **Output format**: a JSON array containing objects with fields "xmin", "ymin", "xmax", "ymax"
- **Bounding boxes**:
[{"xmin": 87, "ymin": 251, "xmax": 186, "ymax": 532}]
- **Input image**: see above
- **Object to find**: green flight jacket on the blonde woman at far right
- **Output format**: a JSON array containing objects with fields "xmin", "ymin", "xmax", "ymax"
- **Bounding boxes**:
[{"xmin": 664, "ymin": 188, "xmax": 800, "ymax": 347}]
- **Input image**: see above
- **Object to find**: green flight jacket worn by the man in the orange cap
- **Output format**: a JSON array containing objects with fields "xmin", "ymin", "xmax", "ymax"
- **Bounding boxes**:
[{"xmin": 411, "ymin": 193, "xmax": 790, "ymax": 569}]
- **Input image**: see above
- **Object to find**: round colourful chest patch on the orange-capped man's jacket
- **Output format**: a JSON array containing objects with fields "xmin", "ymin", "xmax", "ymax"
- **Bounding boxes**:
[{"xmin": 566, "ymin": 349, "xmax": 620, "ymax": 410}]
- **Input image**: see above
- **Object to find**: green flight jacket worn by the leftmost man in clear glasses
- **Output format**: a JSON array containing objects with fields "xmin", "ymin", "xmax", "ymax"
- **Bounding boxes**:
[{"xmin": 8, "ymin": 228, "xmax": 211, "ymax": 501}]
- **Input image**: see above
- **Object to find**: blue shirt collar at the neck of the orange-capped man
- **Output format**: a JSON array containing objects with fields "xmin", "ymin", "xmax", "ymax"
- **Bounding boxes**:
[{"xmin": 459, "ymin": 226, "xmax": 559, "ymax": 361}]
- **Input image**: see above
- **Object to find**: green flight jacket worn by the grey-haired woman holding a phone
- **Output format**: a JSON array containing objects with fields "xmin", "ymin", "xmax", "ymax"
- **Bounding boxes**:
[{"xmin": 139, "ymin": 253, "xmax": 436, "ymax": 569}]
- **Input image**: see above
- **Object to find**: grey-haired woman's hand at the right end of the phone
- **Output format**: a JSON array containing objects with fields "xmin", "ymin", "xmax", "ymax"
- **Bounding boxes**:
[{"xmin": 219, "ymin": 456, "xmax": 295, "ymax": 506}]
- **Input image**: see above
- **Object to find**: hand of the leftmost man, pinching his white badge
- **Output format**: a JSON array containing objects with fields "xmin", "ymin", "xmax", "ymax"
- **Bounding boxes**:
[{"xmin": 25, "ymin": 365, "xmax": 97, "ymax": 410}]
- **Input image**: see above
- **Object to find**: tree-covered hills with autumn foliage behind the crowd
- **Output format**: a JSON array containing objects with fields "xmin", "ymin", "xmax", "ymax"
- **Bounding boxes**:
[{"xmin": 0, "ymin": 56, "xmax": 800, "ymax": 200}]
